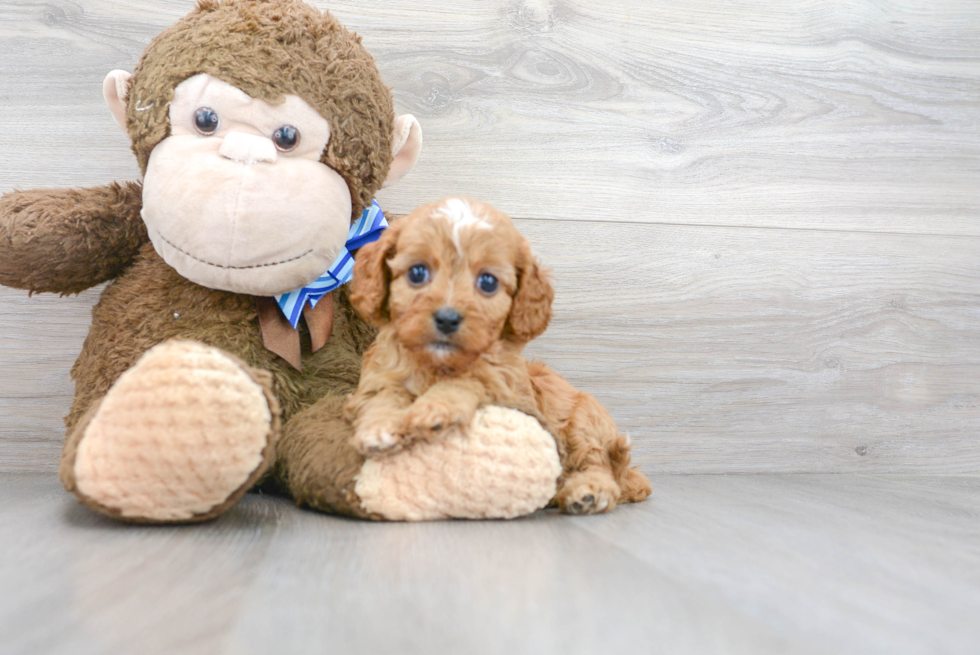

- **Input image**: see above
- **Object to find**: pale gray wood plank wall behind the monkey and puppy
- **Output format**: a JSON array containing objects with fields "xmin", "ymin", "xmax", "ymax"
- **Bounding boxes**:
[{"xmin": 0, "ymin": 0, "xmax": 980, "ymax": 473}]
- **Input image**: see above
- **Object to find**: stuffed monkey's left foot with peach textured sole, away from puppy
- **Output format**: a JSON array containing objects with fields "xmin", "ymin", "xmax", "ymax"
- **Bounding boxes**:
[{"xmin": 62, "ymin": 341, "xmax": 278, "ymax": 522}]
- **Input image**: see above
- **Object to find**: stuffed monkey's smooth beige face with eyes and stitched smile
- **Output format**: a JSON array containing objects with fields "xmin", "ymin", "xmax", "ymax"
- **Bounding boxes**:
[{"xmin": 142, "ymin": 74, "xmax": 351, "ymax": 296}]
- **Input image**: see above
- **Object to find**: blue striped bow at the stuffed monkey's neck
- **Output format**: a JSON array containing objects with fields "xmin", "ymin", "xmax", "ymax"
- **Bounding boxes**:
[{"xmin": 276, "ymin": 200, "xmax": 388, "ymax": 330}]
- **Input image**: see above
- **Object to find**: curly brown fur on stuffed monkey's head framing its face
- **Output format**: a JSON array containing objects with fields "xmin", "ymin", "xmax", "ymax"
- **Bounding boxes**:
[{"xmin": 126, "ymin": 0, "xmax": 395, "ymax": 219}]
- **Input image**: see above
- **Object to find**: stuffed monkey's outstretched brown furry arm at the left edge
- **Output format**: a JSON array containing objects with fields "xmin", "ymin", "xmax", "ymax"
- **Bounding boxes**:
[{"xmin": 0, "ymin": 182, "xmax": 149, "ymax": 294}]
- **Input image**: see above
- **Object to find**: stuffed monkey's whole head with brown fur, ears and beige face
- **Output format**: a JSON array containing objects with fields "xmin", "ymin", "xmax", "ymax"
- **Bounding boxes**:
[{"xmin": 103, "ymin": 0, "xmax": 422, "ymax": 296}]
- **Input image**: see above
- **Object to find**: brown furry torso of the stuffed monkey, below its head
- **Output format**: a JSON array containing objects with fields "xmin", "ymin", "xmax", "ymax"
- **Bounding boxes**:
[{"xmin": 66, "ymin": 245, "xmax": 373, "ymax": 429}]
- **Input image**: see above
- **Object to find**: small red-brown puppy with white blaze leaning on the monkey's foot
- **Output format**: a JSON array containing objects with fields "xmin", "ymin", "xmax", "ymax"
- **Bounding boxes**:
[{"xmin": 346, "ymin": 198, "xmax": 650, "ymax": 514}]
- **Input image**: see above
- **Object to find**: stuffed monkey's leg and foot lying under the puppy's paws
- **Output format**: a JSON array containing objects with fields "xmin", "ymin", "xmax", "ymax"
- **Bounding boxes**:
[{"xmin": 275, "ymin": 396, "xmax": 561, "ymax": 521}]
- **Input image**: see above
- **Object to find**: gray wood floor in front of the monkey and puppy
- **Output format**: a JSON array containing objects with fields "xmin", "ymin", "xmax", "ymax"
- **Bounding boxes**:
[{"xmin": 0, "ymin": 473, "xmax": 980, "ymax": 655}]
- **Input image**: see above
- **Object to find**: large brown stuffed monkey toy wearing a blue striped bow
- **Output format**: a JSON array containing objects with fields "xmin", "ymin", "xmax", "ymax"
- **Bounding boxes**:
[{"xmin": 0, "ymin": 0, "xmax": 560, "ymax": 523}]
